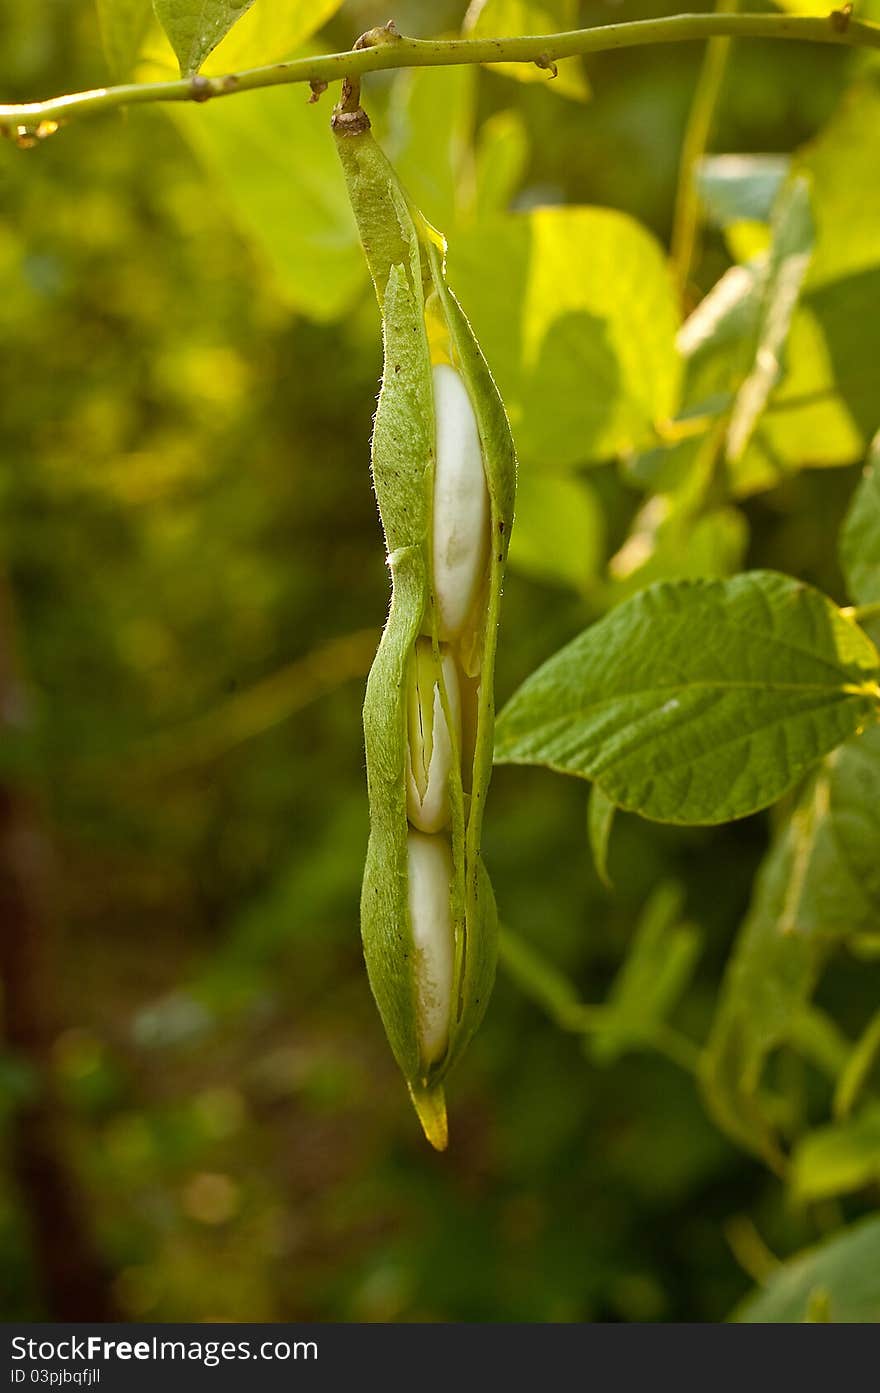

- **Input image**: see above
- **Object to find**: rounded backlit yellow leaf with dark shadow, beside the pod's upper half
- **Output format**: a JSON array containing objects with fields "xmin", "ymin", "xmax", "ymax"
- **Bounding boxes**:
[{"xmin": 450, "ymin": 208, "xmax": 681, "ymax": 468}]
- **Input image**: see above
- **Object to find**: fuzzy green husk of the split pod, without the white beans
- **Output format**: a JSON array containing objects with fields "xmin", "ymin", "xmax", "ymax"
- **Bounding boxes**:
[{"xmin": 334, "ymin": 103, "xmax": 517, "ymax": 1149}]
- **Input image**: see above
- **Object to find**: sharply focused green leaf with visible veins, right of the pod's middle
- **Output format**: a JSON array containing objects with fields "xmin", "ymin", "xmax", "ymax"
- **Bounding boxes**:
[{"xmin": 496, "ymin": 571, "xmax": 880, "ymax": 823}]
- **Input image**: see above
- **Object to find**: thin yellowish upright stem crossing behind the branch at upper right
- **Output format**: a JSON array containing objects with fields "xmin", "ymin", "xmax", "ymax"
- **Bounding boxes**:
[{"xmin": 671, "ymin": 0, "xmax": 737, "ymax": 295}]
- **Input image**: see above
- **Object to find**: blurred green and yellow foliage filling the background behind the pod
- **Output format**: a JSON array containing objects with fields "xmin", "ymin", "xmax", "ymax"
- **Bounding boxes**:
[{"xmin": 0, "ymin": 0, "xmax": 880, "ymax": 1321}]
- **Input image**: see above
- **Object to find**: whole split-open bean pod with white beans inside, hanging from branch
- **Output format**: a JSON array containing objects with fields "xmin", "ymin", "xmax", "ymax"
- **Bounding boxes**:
[{"xmin": 334, "ymin": 95, "xmax": 517, "ymax": 1149}]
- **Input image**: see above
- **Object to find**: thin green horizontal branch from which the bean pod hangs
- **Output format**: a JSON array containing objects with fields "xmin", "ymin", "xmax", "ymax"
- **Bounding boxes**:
[{"xmin": 0, "ymin": 10, "xmax": 880, "ymax": 145}]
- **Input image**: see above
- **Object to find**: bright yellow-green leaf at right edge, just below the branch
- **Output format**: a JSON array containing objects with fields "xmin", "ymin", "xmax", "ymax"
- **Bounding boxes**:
[{"xmin": 794, "ymin": 78, "xmax": 880, "ymax": 288}]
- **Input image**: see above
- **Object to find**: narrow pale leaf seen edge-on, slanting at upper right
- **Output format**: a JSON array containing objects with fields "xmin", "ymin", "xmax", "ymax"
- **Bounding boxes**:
[{"xmin": 727, "ymin": 178, "xmax": 813, "ymax": 464}]
